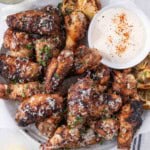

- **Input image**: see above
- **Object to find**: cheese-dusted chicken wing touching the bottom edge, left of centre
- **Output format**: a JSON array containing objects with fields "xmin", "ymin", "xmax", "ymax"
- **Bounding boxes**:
[{"xmin": 40, "ymin": 125, "xmax": 80, "ymax": 150}]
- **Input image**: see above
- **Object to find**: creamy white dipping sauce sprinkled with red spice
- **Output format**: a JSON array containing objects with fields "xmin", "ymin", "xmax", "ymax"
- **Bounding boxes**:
[{"xmin": 91, "ymin": 8, "xmax": 145, "ymax": 63}]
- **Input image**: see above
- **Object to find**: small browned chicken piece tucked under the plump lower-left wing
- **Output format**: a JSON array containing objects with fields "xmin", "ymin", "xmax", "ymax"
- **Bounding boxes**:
[{"xmin": 36, "ymin": 112, "xmax": 62, "ymax": 138}]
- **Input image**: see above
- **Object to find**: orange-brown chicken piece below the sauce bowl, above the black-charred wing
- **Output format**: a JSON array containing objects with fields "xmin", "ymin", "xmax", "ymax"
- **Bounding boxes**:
[{"xmin": 112, "ymin": 71, "xmax": 137, "ymax": 97}]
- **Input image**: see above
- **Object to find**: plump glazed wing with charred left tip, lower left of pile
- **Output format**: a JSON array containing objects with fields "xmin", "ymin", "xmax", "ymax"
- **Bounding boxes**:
[{"xmin": 16, "ymin": 94, "xmax": 63, "ymax": 126}]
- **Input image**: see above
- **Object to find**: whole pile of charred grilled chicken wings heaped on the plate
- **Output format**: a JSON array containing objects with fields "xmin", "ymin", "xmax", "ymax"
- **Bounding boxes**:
[{"xmin": 0, "ymin": 0, "xmax": 143, "ymax": 150}]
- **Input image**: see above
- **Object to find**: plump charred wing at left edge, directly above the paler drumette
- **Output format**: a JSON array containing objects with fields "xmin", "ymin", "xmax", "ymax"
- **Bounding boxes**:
[{"xmin": 0, "ymin": 55, "xmax": 41, "ymax": 83}]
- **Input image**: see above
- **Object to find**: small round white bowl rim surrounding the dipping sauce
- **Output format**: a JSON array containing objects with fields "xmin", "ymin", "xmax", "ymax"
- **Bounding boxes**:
[{"xmin": 88, "ymin": 0, "xmax": 150, "ymax": 69}]
